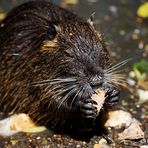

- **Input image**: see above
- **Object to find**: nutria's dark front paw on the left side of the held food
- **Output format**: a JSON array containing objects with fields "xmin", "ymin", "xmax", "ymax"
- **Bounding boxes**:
[{"xmin": 78, "ymin": 99, "xmax": 97, "ymax": 119}]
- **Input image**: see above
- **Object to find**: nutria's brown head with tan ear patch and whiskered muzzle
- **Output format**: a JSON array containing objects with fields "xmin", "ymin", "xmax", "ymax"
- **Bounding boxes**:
[{"xmin": 35, "ymin": 22, "xmax": 118, "ymax": 107}]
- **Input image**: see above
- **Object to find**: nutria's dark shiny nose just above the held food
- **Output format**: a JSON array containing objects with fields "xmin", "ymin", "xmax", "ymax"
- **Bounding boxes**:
[{"xmin": 90, "ymin": 75, "xmax": 103, "ymax": 87}]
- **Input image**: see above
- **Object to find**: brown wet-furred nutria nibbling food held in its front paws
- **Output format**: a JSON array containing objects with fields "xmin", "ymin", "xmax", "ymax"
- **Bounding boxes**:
[{"xmin": 0, "ymin": 1, "xmax": 119, "ymax": 142}]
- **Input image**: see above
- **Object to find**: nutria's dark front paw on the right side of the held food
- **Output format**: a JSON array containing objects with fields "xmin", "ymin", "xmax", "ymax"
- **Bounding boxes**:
[{"xmin": 105, "ymin": 89, "xmax": 120, "ymax": 106}]
